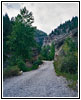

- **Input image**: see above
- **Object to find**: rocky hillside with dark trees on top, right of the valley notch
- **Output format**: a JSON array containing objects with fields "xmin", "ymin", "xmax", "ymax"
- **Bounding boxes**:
[{"xmin": 43, "ymin": 17, "xmax": 78, "ymax": 47}]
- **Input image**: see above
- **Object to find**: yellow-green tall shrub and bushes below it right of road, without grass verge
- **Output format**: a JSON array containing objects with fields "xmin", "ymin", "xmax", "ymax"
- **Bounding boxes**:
[{"xmin": 54, "ymin": 38, "xmax": 78, "ymax": 74}]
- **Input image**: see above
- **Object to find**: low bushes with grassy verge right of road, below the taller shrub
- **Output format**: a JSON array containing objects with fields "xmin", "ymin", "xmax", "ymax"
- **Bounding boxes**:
[{"xmin": 54, "ymin": 55, "xmax": 78, "ymax": 89}]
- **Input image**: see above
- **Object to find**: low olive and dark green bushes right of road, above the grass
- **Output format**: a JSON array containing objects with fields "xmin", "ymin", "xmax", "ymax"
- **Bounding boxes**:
[{"xmin": 54, "ymin": 55, "xmax": 78, "ymax": 74}]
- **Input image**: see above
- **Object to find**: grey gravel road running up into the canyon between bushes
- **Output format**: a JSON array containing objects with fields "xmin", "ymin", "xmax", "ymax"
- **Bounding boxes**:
[{"xmin": 3, "ymin": 61, "xmax": 78, "ymax": 97}]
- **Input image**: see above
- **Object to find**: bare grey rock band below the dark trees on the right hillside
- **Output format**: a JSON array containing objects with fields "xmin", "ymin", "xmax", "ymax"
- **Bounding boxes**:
[{"xmin": 43, "ymin": 28, "xmax": 78, "ymax": 46}]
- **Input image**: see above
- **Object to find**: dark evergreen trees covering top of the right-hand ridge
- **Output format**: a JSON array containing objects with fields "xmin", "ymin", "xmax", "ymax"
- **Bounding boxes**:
[{"xmin": 50, "ymin": 16, "xmax": 78, "ymax": 36}]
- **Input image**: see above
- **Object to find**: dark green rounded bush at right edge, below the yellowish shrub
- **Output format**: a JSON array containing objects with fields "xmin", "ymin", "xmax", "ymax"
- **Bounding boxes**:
[{"xmin": 61, "ymin": 55, "xmax": 77, "ymax": 74}]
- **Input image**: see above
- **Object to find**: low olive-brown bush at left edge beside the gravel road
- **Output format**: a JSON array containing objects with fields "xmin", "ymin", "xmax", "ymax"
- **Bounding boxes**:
[{"xmin": 3, "ymin": 66, "xmax": 20, "ymax": 78}]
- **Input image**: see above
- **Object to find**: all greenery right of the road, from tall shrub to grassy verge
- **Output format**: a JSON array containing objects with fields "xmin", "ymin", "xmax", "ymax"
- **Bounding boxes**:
[{"xmin": 54, "ymin": 35, "xmax": 78, "ymax": 88}]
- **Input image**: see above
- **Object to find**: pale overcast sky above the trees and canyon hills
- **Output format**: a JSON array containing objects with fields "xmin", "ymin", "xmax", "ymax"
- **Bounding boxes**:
[{"xmin": 2, "ymin": 2, "xmax": 78, "ymax": 34}]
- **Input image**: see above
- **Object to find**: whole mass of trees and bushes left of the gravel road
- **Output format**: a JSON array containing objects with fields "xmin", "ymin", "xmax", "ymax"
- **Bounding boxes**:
[{"xmin": 3, "ymin": 7, "xmax": 46, "ymax": 77}]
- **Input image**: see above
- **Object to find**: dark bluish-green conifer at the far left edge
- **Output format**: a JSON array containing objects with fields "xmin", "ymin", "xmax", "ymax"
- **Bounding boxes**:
[{"xmin": 3, "ymin": 14, "xmax": 12, "ymax": 61}]
